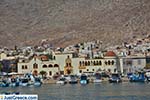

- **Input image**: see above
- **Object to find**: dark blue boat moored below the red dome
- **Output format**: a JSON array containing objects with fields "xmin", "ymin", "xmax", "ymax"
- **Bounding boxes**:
[{"xmin": 109, "ymin": 73, "xmax": 122, "ymax": 83}]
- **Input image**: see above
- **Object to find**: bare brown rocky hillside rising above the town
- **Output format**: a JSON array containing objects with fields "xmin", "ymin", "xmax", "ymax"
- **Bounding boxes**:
[{"xmin": 0, "ymin": 0, "xmax": 150, "ymax": 46}]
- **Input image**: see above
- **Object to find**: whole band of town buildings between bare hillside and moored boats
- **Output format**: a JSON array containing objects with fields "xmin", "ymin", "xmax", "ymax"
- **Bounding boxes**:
[{"xmin": 0, "ymin": 35, "xmax": 150, "ymax": 77}]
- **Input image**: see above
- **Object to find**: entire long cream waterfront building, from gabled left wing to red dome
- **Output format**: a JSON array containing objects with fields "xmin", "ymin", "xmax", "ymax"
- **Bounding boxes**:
[{"xmin": 18, "ymin": 52, "xmax": 118, "ymax": 77}]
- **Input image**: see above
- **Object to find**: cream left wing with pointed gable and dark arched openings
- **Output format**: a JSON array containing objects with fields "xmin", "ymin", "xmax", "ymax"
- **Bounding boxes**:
[{"xmin": 18, "ymin": 55, "xmax": 59, "ymax": 76}]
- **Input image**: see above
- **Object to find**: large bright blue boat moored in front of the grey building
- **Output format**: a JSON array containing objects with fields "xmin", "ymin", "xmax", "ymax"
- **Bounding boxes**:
[{"xmin": 129, "ymin": 72, "xmax": 146, "ymax": 82}]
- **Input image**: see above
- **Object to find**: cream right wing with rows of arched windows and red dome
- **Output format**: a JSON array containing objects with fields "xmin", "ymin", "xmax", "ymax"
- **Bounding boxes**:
[{"xmin": 78, "ymin": 51, "xmax": 118, "ymax": 74}]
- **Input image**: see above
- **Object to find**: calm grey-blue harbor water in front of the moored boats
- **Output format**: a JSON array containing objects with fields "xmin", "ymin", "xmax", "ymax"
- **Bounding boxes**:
[{"xmin": 0, "ymin": 83, "xmax": 150, "ymax": 100}]
